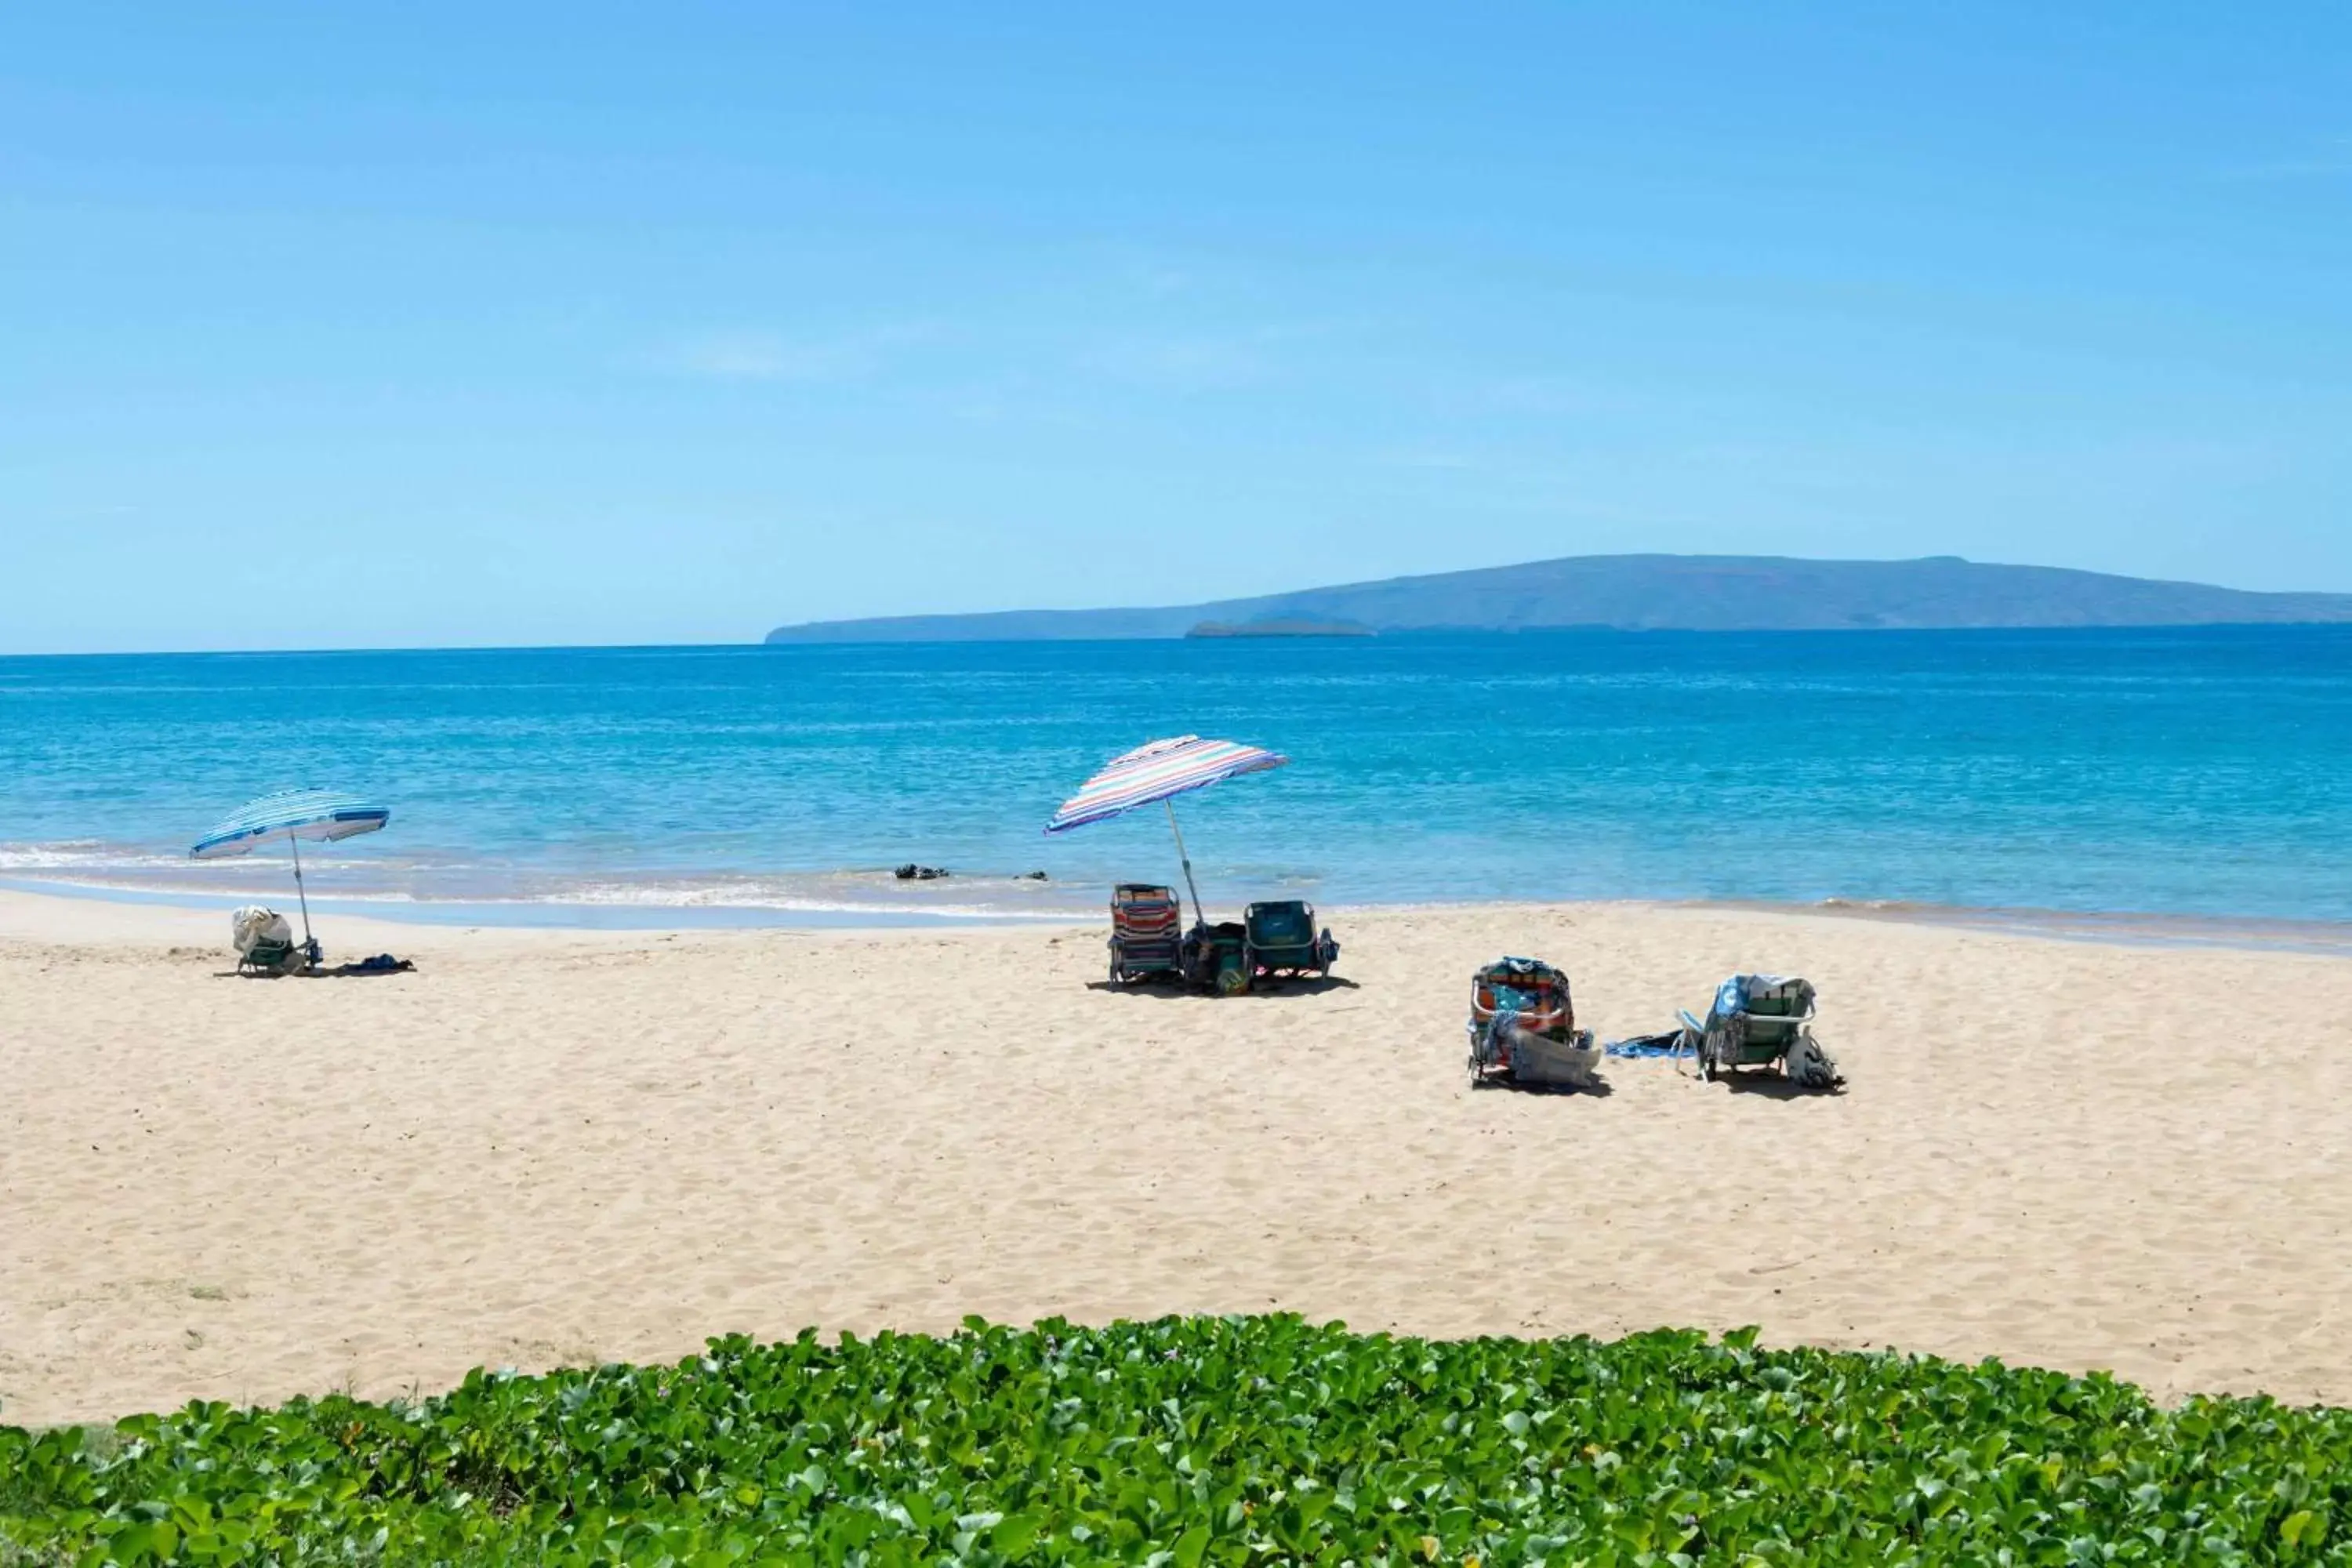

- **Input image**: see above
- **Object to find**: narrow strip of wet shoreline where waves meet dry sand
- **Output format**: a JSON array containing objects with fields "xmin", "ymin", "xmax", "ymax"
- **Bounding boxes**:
[{"xmin": 0, "ymin": 874, "xmax": 2352, "ymax": 956}]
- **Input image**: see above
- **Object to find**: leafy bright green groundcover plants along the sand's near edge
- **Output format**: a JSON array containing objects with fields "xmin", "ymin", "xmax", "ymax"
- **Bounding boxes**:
[{"xmin": 0, "ymin": 1316, "xmax": 2352, "ymax": 1568}]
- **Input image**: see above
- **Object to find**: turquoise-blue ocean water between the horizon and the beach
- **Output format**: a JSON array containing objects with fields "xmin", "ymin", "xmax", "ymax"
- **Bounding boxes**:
[{"xmin": 0, "ymin": 628, "xmax": 2352, "ymax": 926}]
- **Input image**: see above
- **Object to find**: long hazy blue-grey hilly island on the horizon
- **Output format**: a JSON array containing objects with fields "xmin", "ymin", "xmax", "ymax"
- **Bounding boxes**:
[{"xmin": 767, "ymin": 555, "xmax": 2352, "ymax": 644}]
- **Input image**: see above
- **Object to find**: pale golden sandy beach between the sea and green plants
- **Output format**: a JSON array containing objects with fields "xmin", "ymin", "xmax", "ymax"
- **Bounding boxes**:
[{"xmin": 0, "ymin": 893, "xmax": 2352, "ymax": 1425}]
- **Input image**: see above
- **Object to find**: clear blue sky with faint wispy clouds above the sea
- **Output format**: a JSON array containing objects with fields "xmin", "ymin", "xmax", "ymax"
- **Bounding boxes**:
[{"xmin": 0, "ymin": 0, "xmax": 2352, "ymax": 652}]
